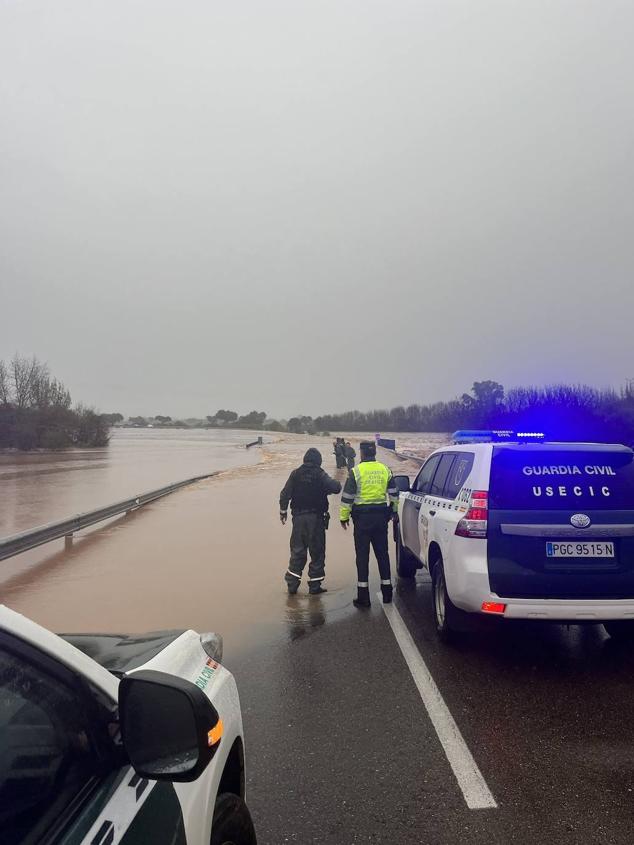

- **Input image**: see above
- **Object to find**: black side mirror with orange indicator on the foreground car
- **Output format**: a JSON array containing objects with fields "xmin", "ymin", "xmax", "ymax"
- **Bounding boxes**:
[{"xmin": 119, "ymin": 669, "xmax": 222, "ymax": 781}]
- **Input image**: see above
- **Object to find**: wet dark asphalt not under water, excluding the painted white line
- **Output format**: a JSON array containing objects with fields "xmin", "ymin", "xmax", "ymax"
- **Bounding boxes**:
[{"xmin": 233, "ymin": 573, "xmax": 634, "ymax": 845}]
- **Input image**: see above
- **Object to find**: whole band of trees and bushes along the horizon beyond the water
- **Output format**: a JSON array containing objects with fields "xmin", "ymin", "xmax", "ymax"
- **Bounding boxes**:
[{"xmin": 6, "ymin": 355, "xmax": 634, "ymax": 450}]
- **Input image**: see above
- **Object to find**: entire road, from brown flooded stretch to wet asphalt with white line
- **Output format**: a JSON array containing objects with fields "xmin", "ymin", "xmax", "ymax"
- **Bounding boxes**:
[{"xmin": 2, "ymin": 438, "xmax": 634, "ymax": 845}]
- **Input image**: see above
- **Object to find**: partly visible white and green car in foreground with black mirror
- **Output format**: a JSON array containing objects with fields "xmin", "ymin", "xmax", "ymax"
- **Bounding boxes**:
[{"xmin": 0, "ymin": 605, "xmax": 256, "ymax": 845}]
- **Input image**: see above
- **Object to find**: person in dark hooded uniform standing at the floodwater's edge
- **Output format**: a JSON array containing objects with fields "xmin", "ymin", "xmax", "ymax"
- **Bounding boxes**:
[{"xmin": 280, "ymin": 449, "xmax": 341, "ymax": 595}]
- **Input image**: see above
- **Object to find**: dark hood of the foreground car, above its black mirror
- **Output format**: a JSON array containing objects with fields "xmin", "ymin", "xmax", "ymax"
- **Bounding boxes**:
[{"xmin": 59, "ymin": 629, "xmax": 185, "ymax": 675}]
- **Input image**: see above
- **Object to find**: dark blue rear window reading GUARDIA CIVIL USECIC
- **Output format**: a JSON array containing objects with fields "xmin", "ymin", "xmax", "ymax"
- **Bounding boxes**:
[{"xmin": 489, "ymin": 446, "xmax": 634, "ymax": 510}]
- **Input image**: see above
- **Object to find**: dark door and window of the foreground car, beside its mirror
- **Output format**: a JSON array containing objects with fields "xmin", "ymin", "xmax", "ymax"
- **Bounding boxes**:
[{"xmin": 0, "ymin": 633, "xmax": 185, "ymax": 845}]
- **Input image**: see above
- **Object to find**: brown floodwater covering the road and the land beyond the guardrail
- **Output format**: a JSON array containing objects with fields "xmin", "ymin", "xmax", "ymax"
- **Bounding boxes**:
[{"xmin": 0, "ymin": 430, "xmax": 444, "ymax": 659}]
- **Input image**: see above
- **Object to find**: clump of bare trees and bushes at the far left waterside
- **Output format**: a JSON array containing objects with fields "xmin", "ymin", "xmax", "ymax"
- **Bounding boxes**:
[{"xmin": 0, "ymin": 355, "xmax": 108, "ymax": 451}]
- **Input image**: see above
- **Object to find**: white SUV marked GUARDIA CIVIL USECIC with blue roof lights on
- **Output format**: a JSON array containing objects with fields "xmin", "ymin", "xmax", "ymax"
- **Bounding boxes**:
[{"xmin": 396, "ymin": 431, "xmax": 634, "ymax": 639}]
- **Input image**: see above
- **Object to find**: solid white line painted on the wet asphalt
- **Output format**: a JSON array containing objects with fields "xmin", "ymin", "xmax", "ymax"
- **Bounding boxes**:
[{"xmin": 378, "ymin": 593, "xmax": 497, "ymax": 810}]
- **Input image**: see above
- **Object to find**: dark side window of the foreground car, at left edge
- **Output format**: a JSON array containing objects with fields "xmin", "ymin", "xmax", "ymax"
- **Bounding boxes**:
[{"xmin": 0, "ymin": 643, "xmax": 97, "ymax": 845}]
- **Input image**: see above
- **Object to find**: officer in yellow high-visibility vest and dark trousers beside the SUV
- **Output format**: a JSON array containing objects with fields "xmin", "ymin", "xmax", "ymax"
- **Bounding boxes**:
[{"xmin": 339, "ymin": 440, "xmax": 398, "ymax": 607}]
